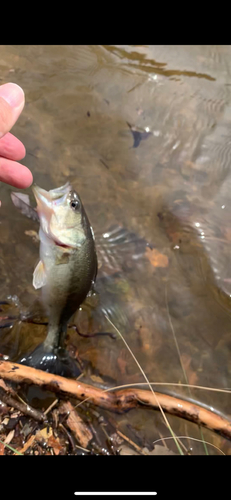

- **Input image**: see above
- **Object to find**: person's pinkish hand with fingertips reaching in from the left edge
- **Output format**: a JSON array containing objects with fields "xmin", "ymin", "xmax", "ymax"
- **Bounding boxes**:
[{"xmin": 0, "ymin": 83, "xmax": 33, "ymax": 188}]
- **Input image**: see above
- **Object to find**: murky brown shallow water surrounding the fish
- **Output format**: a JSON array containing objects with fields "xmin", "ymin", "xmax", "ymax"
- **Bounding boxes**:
[{"xmin": 0, "ymin": 46, "xmax": 231, "ymax": 453}]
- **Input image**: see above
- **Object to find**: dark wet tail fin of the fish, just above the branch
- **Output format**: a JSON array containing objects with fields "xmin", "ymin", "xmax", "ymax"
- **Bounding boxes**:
[{"xmin": 18, "ymin": 343, "xmax": 82, "ymax": 378}]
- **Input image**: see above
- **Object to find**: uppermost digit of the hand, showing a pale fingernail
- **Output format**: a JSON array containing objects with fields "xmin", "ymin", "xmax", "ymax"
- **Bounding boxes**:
[{"xmin": 0, "ymin": 83, "xmax": 25, "ymax": 139}]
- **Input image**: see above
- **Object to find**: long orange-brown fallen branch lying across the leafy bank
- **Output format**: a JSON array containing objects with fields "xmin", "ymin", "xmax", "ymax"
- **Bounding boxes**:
[{"xmin": 0, "ymin": 361, "xmax": 231, "ymax": 439}]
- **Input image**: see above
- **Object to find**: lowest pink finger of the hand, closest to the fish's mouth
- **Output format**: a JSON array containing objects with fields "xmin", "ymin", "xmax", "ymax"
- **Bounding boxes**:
[{"xmin": 0, "ymin": 158, "xmax": 33, "ymax": 189}]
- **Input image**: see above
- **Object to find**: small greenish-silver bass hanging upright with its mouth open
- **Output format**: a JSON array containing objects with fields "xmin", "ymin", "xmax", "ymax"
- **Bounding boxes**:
[{"xmin": 19, "ymin": 182, "xmax": 98, "ymax": 377}]
